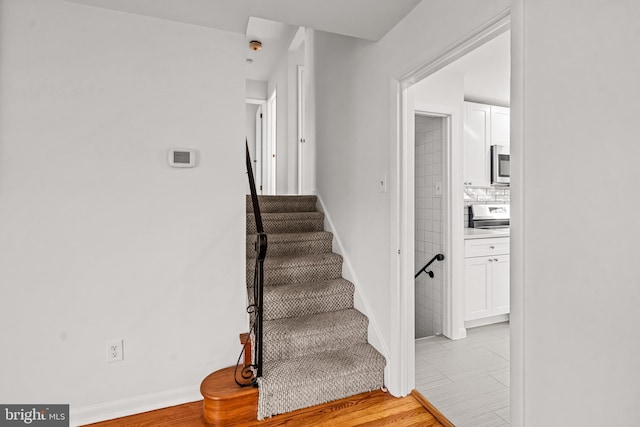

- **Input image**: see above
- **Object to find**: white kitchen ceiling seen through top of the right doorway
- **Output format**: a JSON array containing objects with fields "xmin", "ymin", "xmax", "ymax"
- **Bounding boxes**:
[{"xmin": 443, "ymin": 31, "xmax": 511, "ymax": 107}]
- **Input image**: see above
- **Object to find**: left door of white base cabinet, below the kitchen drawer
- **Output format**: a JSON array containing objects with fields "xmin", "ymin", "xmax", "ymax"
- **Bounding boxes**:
[{"xmin": 464, "ymin": 257, "xmax": 491, "ymax": 320}]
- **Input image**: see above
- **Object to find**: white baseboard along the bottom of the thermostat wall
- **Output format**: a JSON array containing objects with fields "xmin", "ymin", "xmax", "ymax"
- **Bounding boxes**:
[{"xmin": 69, "ymin": 384, "xmax": 202, "ymax": 427}]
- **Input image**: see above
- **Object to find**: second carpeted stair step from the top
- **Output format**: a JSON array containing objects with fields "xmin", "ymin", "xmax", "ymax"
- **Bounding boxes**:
[{"xmin": 247, "ymin": 212, "xmax": 324, "ymax": 234}]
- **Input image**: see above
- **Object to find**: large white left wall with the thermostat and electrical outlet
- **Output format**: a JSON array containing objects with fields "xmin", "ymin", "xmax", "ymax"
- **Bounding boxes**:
[{"xmin": 0, "ymin": 0, "xmax": 247, "ymax": 422}]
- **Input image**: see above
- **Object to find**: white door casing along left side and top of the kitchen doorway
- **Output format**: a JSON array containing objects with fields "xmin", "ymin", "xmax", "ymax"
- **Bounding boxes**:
[{"xmin": 390, "ymin": 7, "xmax": 511, "ymax": 395}]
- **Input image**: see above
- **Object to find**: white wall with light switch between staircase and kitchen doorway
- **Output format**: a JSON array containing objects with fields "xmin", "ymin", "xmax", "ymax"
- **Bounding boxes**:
[{"xmin": 307, "ymin": 0, "xmax": 509, "ymax": 394}]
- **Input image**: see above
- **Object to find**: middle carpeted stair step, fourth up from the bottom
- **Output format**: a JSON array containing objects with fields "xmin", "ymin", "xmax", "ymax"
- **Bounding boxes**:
[{"xmin": 246, "ymin": 253, "xmax": 342, "ymax": 287}]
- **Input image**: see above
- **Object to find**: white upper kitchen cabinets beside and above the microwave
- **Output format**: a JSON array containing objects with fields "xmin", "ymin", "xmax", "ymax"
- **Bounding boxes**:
[{"xmin": 463, "ymin": 102, "xmax": 511, "ymax": 187}]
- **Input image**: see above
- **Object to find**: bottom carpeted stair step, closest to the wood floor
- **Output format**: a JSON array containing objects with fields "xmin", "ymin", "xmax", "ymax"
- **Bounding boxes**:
[{"xmin": 258, "ymin": 343, "xmax": 386, "ymax": 419}]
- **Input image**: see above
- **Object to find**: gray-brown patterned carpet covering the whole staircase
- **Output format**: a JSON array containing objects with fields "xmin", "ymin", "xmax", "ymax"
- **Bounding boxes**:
[{"xmin": 246, "ymin": 196, "xmax": 386, "ymax": 420}]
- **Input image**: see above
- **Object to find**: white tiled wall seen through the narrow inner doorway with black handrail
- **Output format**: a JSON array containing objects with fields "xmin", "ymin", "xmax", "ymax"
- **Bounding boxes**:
[{"xmin": 415, "ymin": 116, "xmax": 444, "ymax": 338}]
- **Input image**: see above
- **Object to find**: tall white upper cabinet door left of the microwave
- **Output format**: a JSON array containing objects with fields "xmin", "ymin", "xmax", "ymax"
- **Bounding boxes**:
[{"xmin": 463, "ymin": 102, "xmax": 491, "ymax": 186}]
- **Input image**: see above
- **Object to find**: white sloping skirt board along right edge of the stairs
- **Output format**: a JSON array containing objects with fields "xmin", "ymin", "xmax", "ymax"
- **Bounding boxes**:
[{"xmin": 316, "ymin": 194, "xmax": 390, "ymax": 392}]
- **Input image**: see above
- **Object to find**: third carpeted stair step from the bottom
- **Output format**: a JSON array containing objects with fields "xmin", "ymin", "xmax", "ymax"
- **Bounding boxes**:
[{"xmin": 262, "ymin": 278, "xmax": 354, "ymax": 320}]
